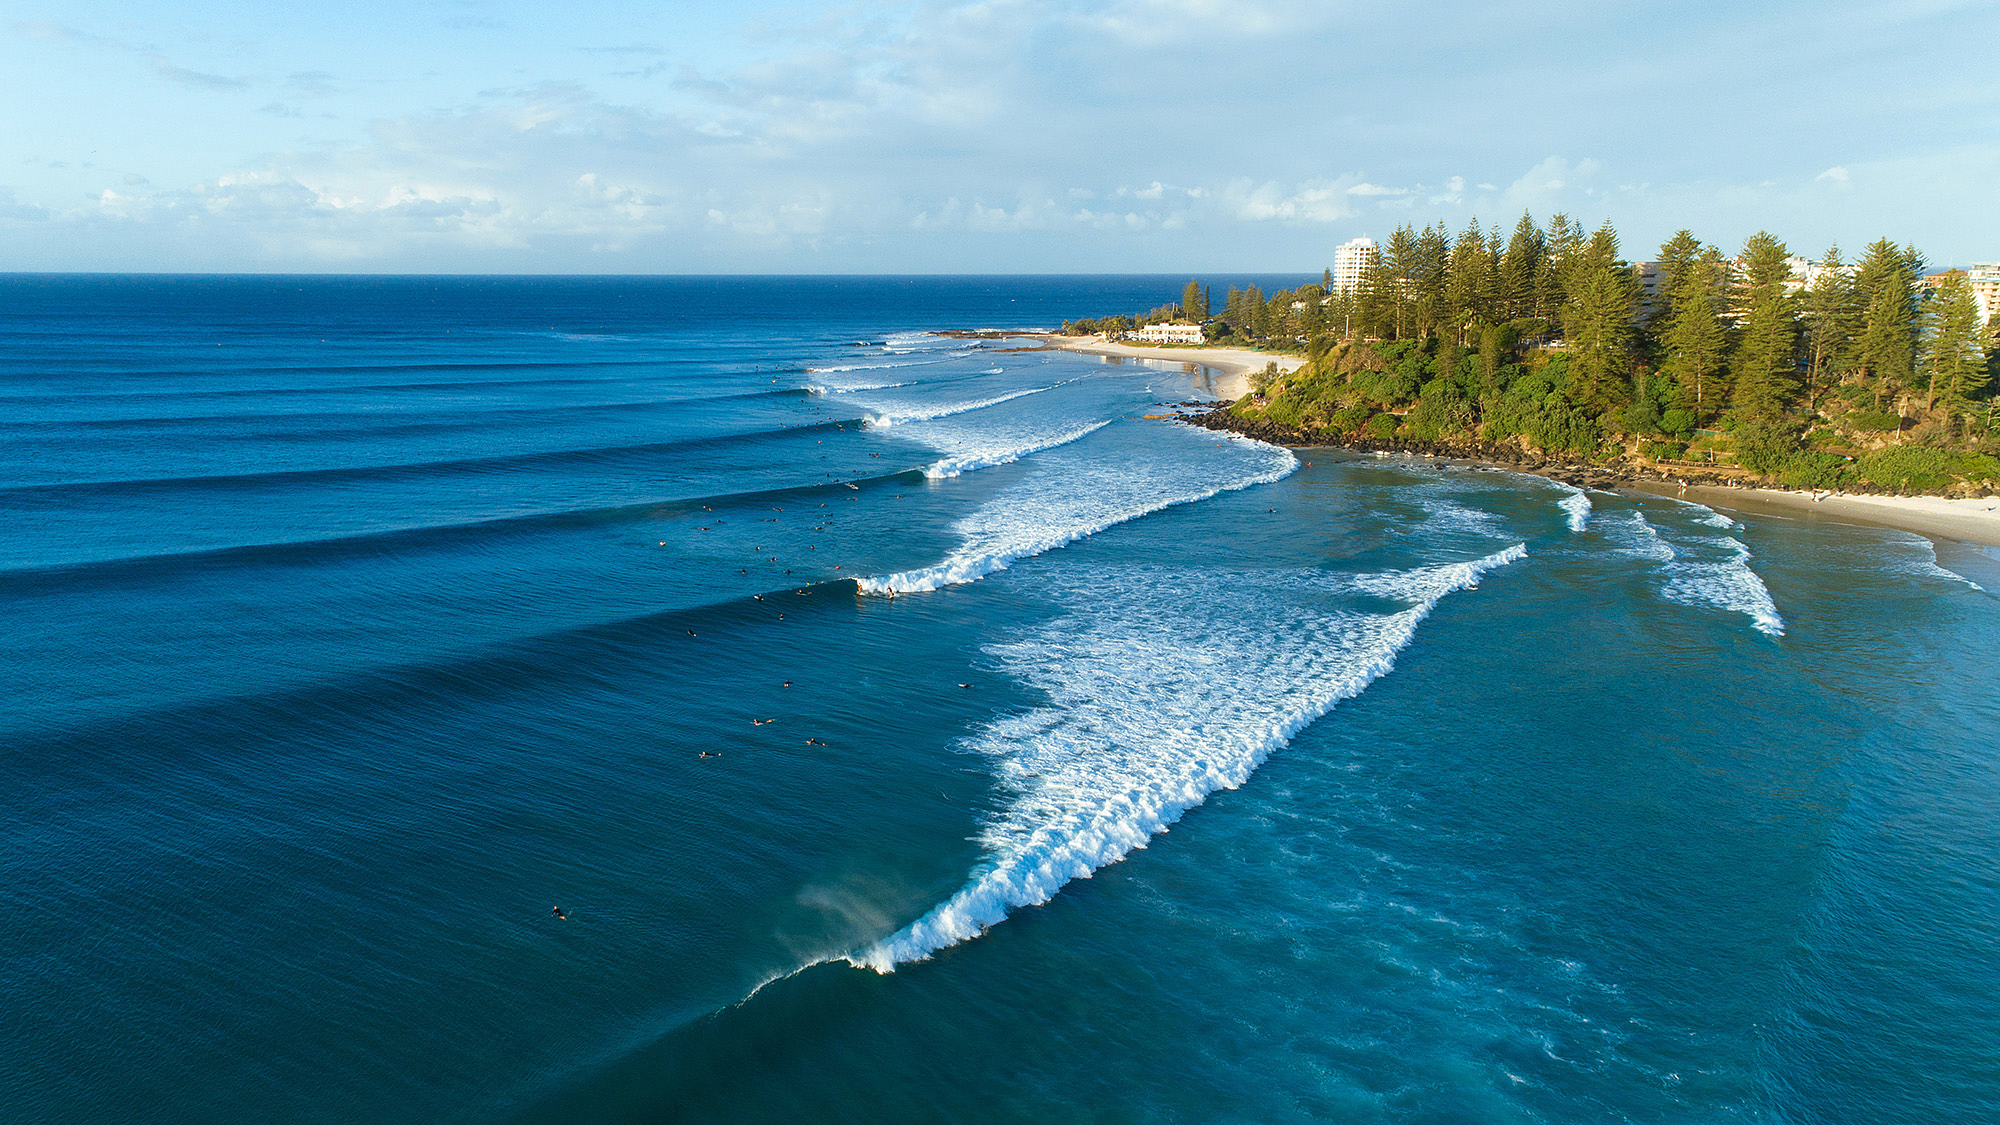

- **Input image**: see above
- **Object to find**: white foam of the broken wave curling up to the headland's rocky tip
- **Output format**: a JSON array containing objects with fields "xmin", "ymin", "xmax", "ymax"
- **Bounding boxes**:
[{"xmin": 858, "ymin": 430, "xmax": 1298, "ymax": 595}]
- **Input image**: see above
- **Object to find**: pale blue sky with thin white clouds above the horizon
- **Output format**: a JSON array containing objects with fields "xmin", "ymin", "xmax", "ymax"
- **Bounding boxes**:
[{"xmin": 0, "ymin": 0, "xmax": 2000, "ymax": 274}]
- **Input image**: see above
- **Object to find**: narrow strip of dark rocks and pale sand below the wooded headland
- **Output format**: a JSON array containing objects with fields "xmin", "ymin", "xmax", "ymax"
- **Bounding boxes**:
[{"xmin": 1182, "ymin": 408, "xmax": 2000, "ymax": 546}]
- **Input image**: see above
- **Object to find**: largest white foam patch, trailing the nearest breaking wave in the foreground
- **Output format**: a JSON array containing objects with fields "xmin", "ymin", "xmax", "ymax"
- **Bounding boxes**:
[{"xmin": 848, "ymin": 544, "xmax": 1526, "ymax": 973}]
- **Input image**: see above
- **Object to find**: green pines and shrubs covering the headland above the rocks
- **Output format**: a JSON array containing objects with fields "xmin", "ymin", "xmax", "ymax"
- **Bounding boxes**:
[{"xmin": 1088, "ymin": 214, "xmax": 2000, "ymax": 492}]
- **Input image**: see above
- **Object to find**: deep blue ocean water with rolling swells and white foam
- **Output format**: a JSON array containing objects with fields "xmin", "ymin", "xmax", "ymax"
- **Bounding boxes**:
[{"xmin": 0, "ymin": 276, "xmax": 2000, "ymax": 1123}]
